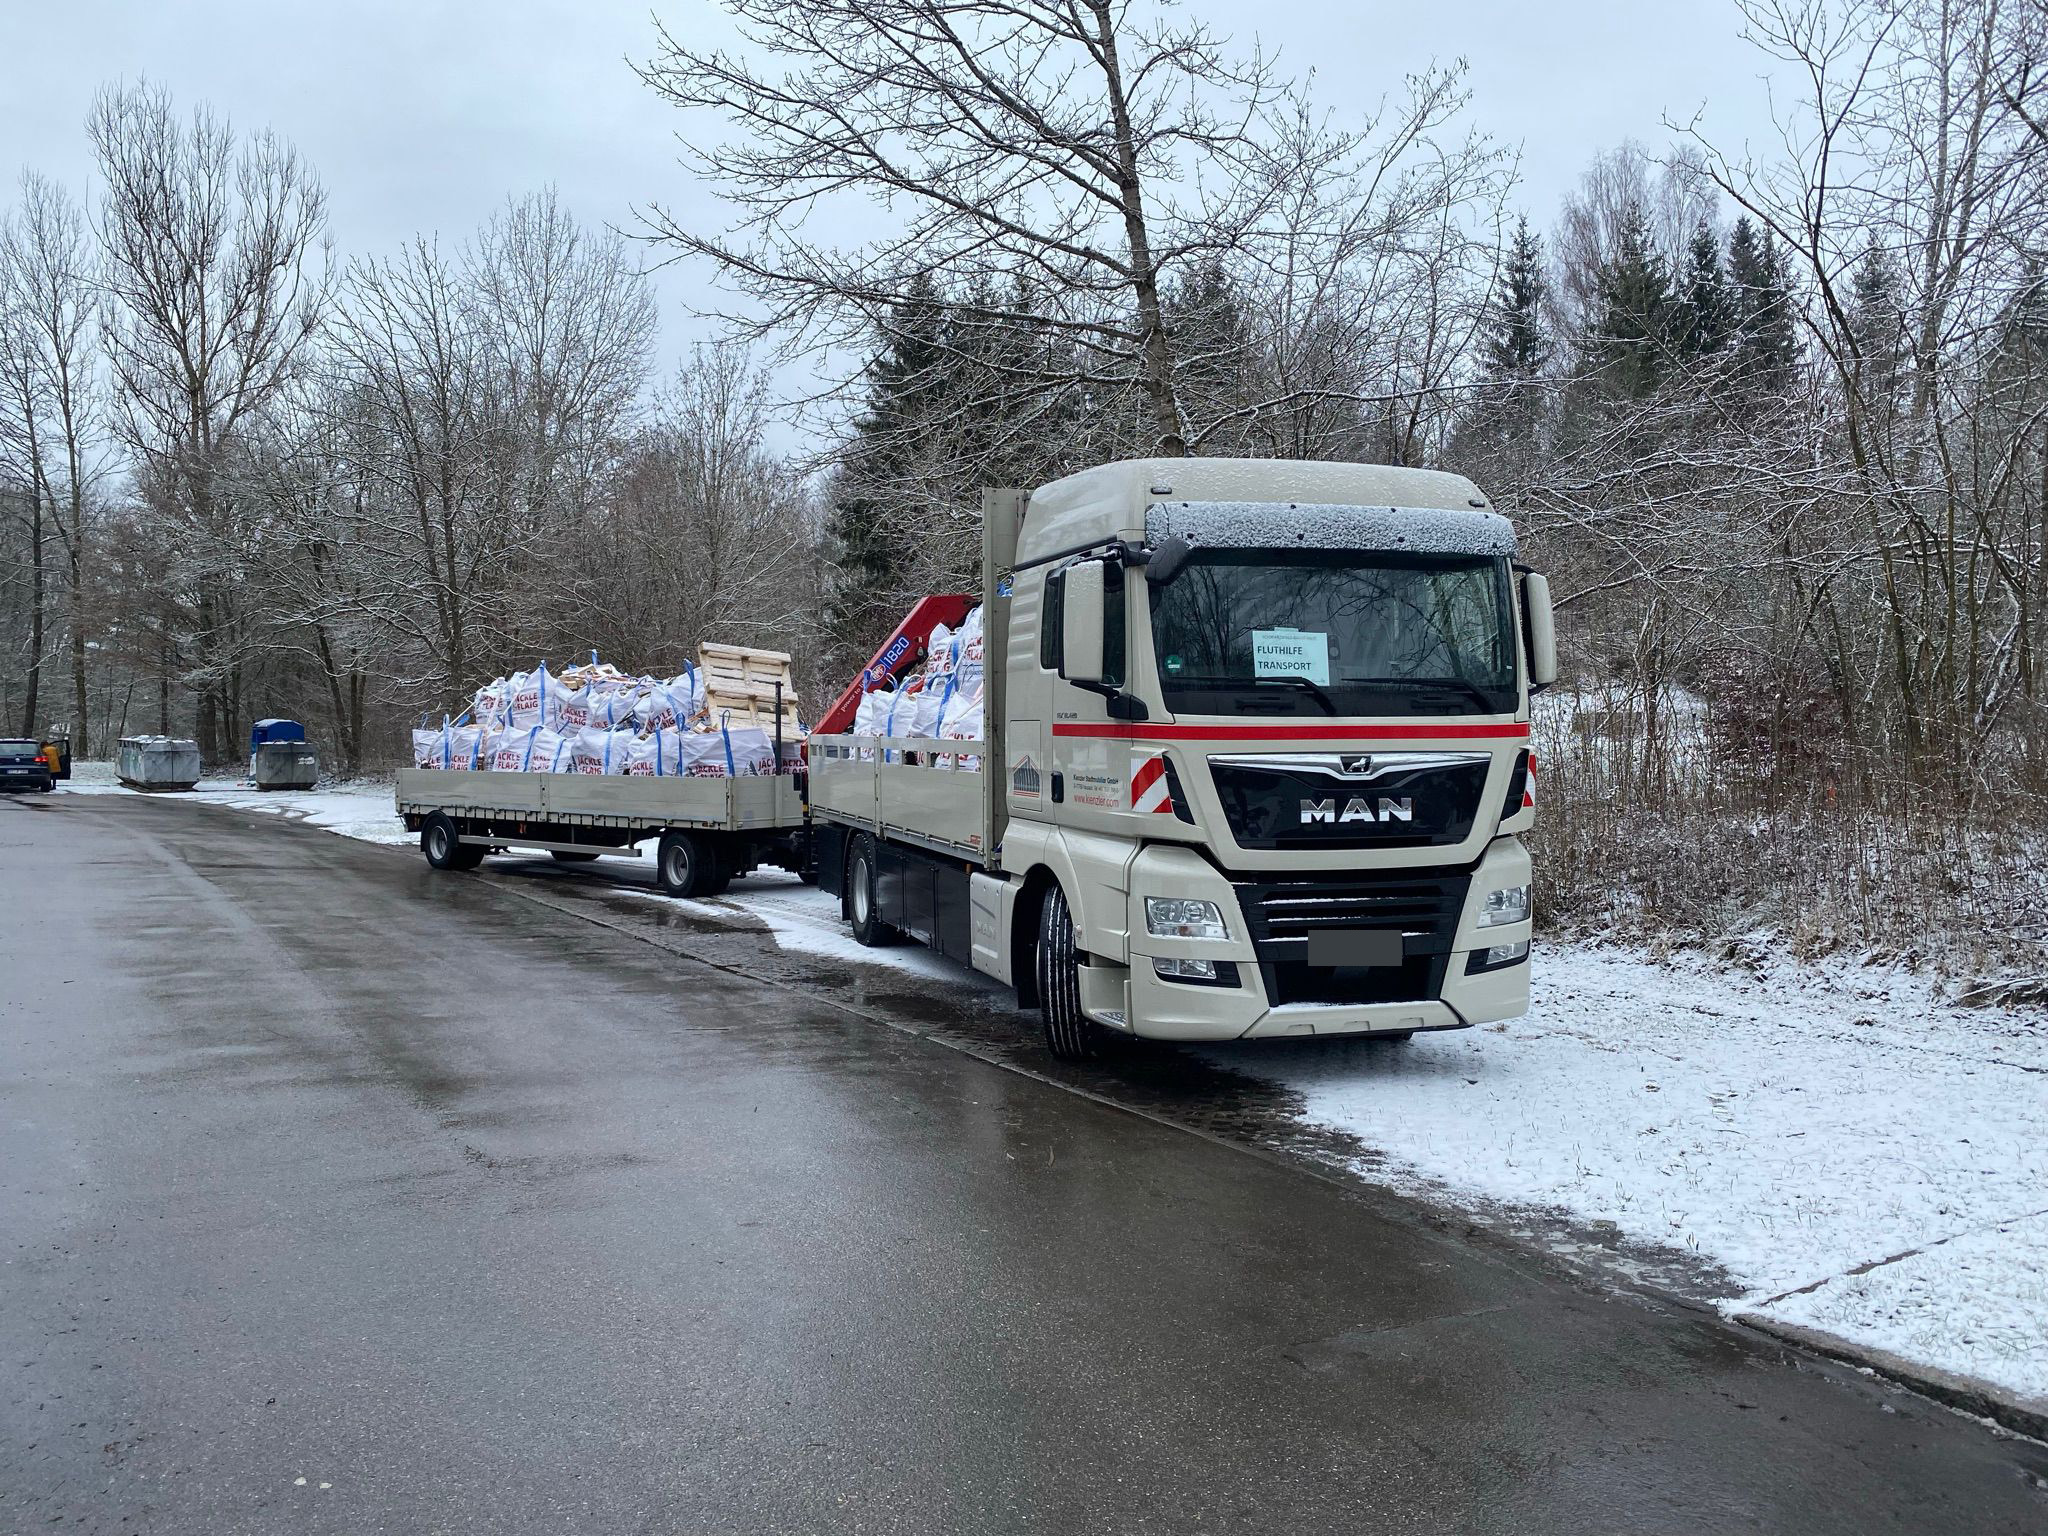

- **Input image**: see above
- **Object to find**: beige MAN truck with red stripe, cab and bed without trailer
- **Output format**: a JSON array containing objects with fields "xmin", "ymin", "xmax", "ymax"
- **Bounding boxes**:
[{"xmin": 809, "ymin": 459, "xmax": 1556, "ymax": 1057}]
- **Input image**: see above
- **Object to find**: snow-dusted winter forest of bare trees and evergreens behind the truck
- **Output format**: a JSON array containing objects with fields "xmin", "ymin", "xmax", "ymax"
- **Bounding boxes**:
[{"xmin": 0, "ymin": 0, "xmax": 2048, "ymax": 974}]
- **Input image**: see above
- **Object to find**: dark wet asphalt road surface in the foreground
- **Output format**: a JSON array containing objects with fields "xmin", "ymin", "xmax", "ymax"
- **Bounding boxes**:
[{"xmin": 0, "ymin": 797, "xmax": 2048, "ymax": 1536}]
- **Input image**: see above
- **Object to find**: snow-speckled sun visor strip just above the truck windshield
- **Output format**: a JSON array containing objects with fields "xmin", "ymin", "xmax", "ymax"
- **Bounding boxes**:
[{"xmin": 1145, "ymin": 502, "xmax": 1516, "ymax": 555}]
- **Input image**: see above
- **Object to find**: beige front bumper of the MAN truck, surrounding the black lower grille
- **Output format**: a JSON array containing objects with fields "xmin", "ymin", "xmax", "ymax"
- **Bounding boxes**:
[{"xmin": 1114, "ymin": 838, "xmax": 1530, "ymax": 1040}]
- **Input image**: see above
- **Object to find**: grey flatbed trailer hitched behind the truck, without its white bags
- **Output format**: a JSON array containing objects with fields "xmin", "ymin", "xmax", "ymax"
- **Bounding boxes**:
[{"xmin": 397, "ymin": 768, "xmax": 809, "ymax": 897}]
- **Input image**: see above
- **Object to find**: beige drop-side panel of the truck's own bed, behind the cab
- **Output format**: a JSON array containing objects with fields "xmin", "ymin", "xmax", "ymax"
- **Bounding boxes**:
[{"xmin": 811, "ymin": 735, "xmax": 989, "ymax": 864}]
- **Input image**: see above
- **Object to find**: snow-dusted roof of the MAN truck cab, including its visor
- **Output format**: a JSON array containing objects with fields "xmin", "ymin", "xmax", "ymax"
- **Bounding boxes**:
[{"xmin": 1018, "ymin": 459, "xmax": 1516, "ymax": 561}]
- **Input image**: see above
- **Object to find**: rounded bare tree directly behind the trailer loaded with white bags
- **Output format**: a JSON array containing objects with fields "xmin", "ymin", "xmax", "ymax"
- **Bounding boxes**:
[{"xmin": 322, "ymin": 195, "xmax": 653, "ymax": 711}]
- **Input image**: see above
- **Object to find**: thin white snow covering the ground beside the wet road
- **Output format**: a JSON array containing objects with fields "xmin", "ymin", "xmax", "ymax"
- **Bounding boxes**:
[{"xmin": 68, "ymin": 764, "xmax": 2048, "ymax": 1403}]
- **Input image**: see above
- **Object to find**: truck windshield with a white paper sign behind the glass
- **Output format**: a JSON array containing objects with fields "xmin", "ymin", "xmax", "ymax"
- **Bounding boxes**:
[{"xmin": 1149, "ymin": 549, "xmax": 1516, "ymax": 715}]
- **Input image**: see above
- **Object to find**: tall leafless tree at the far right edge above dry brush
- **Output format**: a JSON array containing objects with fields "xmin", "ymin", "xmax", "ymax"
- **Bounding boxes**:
[{"xmin": 1679, "ymin": 0, "xmax": 2048, "ymax": 766}]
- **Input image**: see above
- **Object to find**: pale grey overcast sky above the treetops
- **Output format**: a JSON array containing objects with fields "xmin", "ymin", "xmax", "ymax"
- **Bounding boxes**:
[{"xmin": 0, "ymin": 0, "xmax": 1769, "ymax": 430}]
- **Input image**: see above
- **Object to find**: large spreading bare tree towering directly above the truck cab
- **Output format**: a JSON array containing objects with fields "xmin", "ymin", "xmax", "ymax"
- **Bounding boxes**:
[{"xmin": 641, "ymin": 0, "xmax": 1487, "ymax": 453}]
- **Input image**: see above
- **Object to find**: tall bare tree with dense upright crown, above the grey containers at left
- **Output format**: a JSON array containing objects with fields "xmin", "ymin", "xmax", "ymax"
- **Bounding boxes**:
[{"xmin": 88, "ymin": 84, "xmax": 328, "ymax": 756}]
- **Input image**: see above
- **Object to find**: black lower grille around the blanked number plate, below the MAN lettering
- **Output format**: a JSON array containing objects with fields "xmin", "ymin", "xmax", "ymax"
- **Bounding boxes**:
[{"xmin": 1237, "ymin": 870, "xmax": 1470, "ymax": 1006}]
